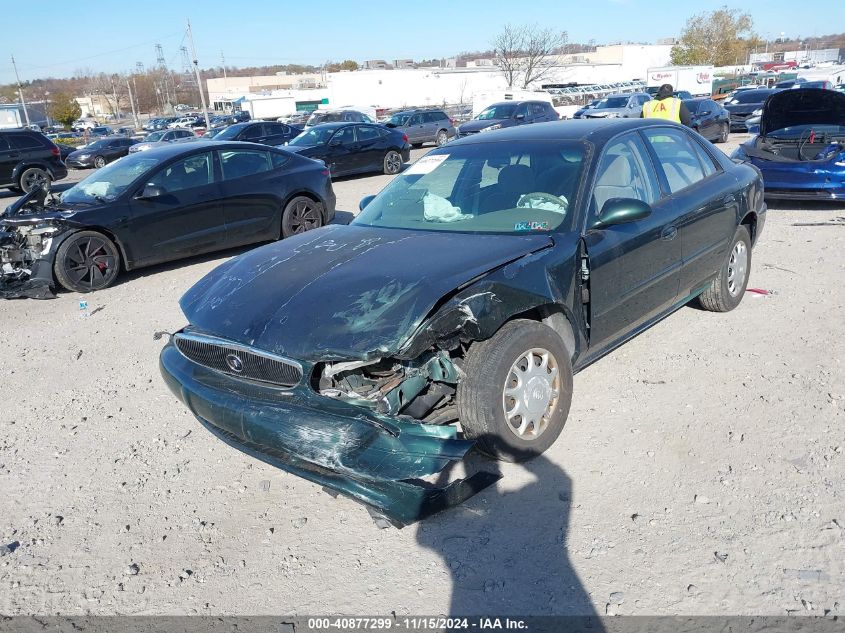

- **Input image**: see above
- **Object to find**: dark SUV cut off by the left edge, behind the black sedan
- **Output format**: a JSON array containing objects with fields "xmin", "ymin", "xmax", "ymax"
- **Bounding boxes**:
[{"xmin": 0, "ymin": 129, "xmax": 67, "ymax": 193}]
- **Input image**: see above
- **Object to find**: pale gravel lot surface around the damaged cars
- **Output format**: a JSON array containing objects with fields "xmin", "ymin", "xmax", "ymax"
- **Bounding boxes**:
[{"xmin": 0, "ymin": 138, "xmax": 845, "ymax": 616}]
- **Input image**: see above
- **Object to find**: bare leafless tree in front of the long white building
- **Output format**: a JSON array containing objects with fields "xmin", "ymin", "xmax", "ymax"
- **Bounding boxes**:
[{"xmin": 492, "ymin": 24, "xmax": 568, "ymax": 88}]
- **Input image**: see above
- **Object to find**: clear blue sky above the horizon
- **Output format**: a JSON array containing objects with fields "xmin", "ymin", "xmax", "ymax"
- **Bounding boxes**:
[{"xmin": 0, "ymin": 0, "xmax": 845, "ymax": 84}]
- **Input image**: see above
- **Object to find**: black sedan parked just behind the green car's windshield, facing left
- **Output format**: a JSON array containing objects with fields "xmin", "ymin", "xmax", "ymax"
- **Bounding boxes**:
[{"xmin": 284, "ymin": 123, "xmax": 411, "ymax": 176}]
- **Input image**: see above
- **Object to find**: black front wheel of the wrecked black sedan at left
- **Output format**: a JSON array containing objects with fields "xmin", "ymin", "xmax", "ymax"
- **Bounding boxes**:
[{"xmin": 53, "ymin": 231, "xmax": 120, "ymax": 292}]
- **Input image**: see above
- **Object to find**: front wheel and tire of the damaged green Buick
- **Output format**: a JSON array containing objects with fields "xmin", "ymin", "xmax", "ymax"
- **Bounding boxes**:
[{"xmin": 457, "ymin": 319, "xmax": 572, "ymax": 462}]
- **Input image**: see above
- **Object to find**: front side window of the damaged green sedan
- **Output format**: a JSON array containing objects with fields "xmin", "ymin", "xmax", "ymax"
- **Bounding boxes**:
[{"xmin": 590, "ymin": 134, "xmax": 660, "ymax": 216}]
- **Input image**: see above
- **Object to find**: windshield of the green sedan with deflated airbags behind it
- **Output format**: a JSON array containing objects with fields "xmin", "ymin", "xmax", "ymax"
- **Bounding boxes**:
[{"xmin": 352, "ymin": 141, "xmax": 586, "ymax": 235}]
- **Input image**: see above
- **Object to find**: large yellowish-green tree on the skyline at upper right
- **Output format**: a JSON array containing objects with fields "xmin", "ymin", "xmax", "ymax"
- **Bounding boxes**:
[{"xmin": 671, "ymin": 6, "xmax": 760, "ymax": 66}]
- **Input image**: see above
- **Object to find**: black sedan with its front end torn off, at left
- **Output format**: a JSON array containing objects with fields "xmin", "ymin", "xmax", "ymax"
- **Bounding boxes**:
[{"xmin": 0, "ymin": 143, "xmax": 335, "ymax": 296}]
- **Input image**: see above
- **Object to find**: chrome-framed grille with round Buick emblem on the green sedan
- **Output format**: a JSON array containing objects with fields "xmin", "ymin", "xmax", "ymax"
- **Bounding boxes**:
[{"xmin": 173, "ymin": 332, "xmax": 302, "ymax": 387}]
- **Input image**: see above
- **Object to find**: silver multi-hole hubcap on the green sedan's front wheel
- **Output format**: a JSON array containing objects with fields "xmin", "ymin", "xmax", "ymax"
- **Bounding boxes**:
[{"xmin": 502, "ymin": 348, "xmax": 560, "ymax": 440}]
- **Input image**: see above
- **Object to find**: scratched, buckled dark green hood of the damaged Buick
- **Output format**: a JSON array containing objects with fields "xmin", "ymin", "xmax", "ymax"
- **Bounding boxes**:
[{"xmin": 180, "ymin": 225, "xmax": 553, "ymax": 362}]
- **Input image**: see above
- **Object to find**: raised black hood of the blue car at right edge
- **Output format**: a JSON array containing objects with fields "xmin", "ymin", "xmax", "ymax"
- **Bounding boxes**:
[{"xmin": 760, "ymin": 88, "xmax": 845, "ymax": 136}]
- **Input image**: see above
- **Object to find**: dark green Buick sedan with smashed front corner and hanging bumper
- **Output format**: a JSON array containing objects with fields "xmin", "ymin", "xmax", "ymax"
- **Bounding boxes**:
[{"xmin": 161, "ymin": 119, "xmax": 766, "ymax": 522}]
